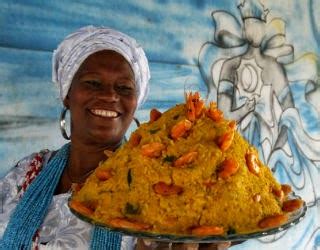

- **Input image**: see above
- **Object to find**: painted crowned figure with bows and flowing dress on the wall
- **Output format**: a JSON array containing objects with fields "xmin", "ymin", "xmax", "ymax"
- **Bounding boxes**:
[{"xmin": 198, "ymin": 0, "xmax": 320, "ymax": 248}]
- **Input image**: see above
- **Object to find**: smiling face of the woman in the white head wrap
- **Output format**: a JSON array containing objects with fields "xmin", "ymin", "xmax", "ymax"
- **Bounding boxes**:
[{"xmin": 64, "ymin": 50, "xmax": 137, "ymax": 148}]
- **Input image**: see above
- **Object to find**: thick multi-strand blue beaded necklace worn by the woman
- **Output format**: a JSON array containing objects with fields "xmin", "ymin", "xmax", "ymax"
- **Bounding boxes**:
[{"xmin": 0, "ymin": 143, "xmax": 121, "ymax": 250}]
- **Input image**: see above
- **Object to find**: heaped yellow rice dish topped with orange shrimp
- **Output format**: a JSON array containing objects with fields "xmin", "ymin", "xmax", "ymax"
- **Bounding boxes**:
[{"xmin": 69, "ymin": 93, "xmax": 303, "ymax": 236}]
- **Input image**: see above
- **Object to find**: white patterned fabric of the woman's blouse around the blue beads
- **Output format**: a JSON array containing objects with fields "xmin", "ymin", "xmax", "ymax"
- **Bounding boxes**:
[{"xmin": 0, "ymin": 152, "xmax": 136, "ymax": 250}]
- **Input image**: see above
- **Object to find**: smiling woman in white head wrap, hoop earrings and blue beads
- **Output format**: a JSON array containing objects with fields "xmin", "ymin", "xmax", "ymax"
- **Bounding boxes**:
[{"xmin": 0, "ymin": 26, "xmax": 150, "ymax": 249}]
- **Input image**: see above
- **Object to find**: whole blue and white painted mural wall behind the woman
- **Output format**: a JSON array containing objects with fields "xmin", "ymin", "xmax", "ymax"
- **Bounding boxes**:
[{"xmin": 0, "ymin": 0, "xmax": 320, "ymax": 249}]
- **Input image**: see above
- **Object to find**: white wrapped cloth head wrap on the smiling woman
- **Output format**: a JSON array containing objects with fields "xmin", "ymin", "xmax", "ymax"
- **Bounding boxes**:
[{"xmin": 52, "ymin": 26, "xmax": 150, "ymax": 106}]
